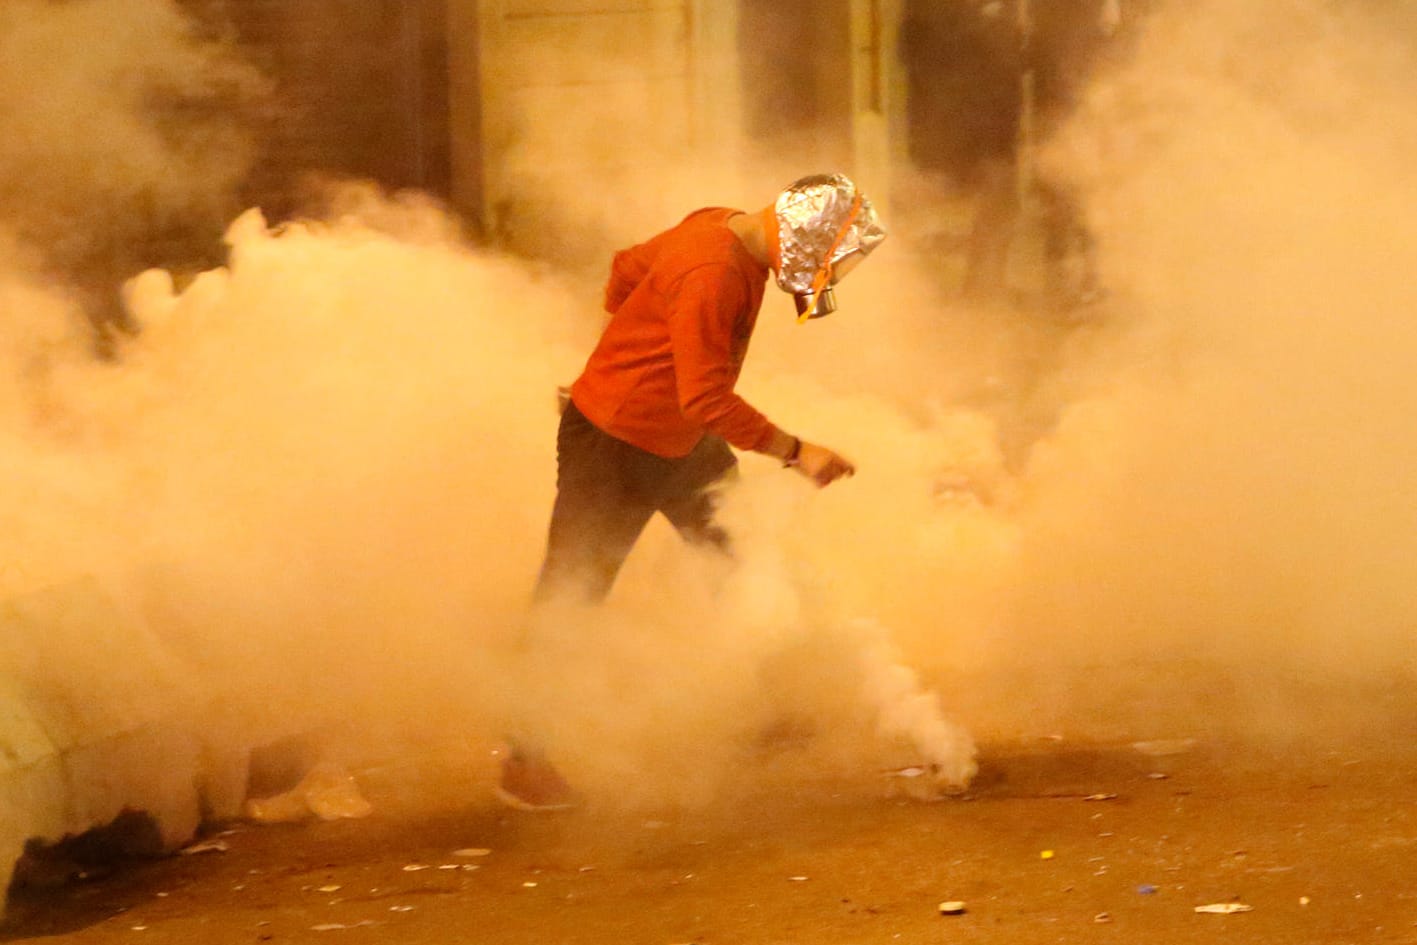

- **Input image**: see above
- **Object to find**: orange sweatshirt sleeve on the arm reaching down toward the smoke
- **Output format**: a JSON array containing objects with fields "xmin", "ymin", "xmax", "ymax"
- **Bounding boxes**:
[{"xmin": 669, "ymin": 260, "xmax": 772, "ymax": 451}]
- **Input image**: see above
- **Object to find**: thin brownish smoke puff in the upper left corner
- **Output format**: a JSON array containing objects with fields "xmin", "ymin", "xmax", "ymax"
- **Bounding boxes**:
[{"xmin": 0, "ymin": 0, "xmax": 266, "ymax": 275}]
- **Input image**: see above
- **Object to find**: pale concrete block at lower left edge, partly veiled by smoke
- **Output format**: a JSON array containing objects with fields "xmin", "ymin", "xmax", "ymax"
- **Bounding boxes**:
[{"xmin": 0, "ymin": 579, "xmax": 209, "ymax": 901}]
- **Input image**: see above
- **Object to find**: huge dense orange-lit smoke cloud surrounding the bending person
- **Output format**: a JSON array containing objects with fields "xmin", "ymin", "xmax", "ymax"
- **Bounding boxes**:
[{"xmin": 0, "ymin": 0, "xmax": 1417, "ymax": 821}]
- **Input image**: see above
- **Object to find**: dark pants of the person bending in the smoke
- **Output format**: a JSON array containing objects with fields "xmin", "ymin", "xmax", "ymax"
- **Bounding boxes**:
[{"xmin": 536, "ymin": 404, "xmax": 737, "ymax": 602}]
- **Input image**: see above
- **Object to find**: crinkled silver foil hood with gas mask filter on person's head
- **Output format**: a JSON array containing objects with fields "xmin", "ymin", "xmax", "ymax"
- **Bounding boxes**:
[{"xmin": 774, "ymin": 174, "xmax": 886, "ymax": 322}]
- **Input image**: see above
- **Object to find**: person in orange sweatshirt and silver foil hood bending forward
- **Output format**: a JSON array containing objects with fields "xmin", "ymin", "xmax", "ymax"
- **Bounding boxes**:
[{"xmin": 497, "ymin": 174, "xmax": 886, "ymax": 810}]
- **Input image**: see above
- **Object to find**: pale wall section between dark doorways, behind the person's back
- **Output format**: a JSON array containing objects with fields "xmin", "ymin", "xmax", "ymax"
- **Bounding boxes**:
[{"xmin": 449, "ymin": 0, "xmax": 741, "ymax": 262}]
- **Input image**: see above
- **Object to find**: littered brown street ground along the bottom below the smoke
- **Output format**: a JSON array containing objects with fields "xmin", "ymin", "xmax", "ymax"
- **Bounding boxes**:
[{"xmin": 7, "ymin": 738, "xmax": 1417, "ymax": 945}]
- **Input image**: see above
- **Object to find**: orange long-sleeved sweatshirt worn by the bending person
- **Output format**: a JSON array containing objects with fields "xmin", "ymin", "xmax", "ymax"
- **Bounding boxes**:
[{"xmin": 571, "ymin": 207, "xmax": 772, "ymax": 458}]
